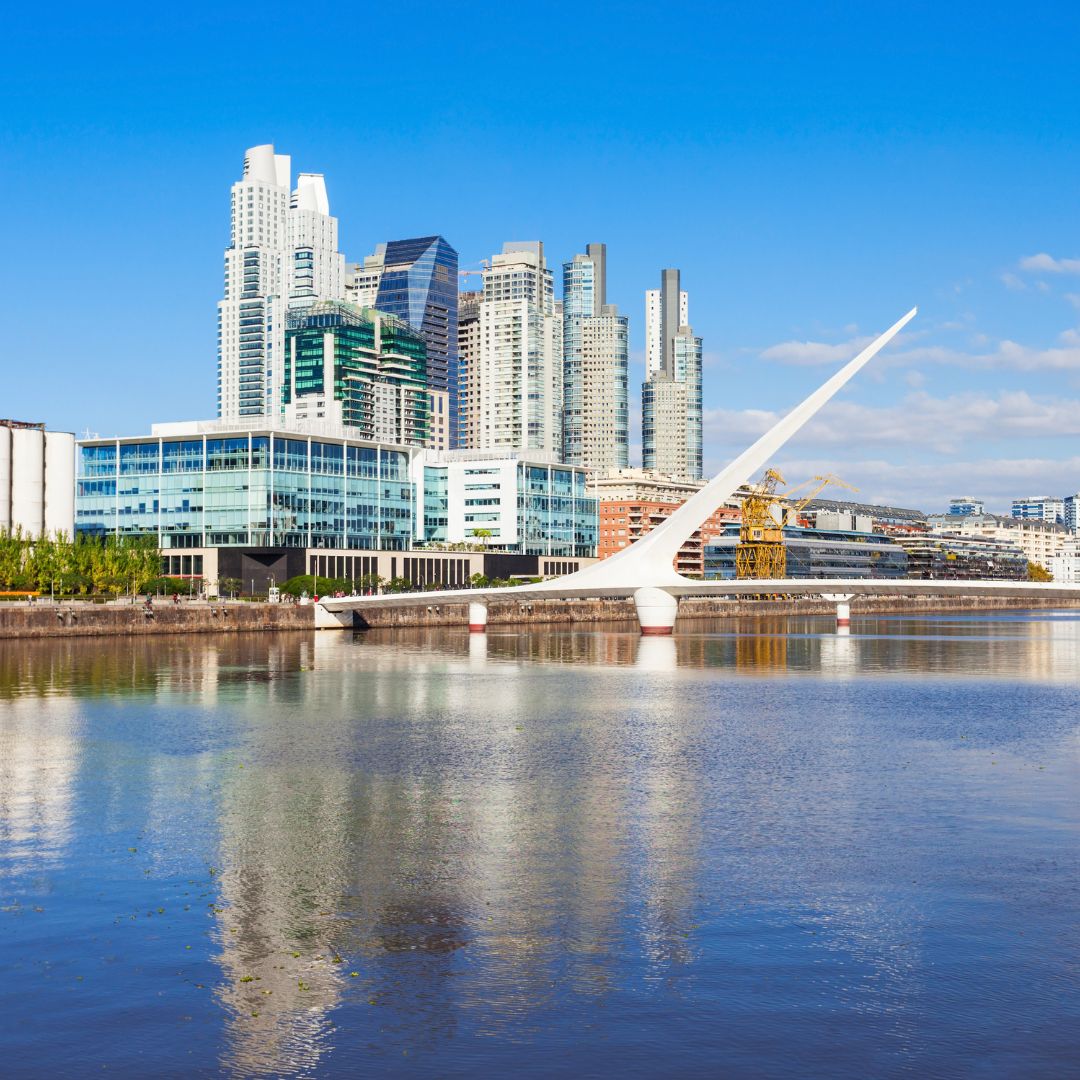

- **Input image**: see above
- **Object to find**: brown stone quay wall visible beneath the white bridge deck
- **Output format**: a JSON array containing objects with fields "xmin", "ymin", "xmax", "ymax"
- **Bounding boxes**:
[{"xmin": 355, "ymin": 593, "xmax": 1080, "ymax": 630}]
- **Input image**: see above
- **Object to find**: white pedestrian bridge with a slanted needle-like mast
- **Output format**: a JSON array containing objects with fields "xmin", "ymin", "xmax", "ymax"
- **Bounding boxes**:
[{"xmin": 316, "ymin": 308, "xmax": 1080, "ymax": 635}]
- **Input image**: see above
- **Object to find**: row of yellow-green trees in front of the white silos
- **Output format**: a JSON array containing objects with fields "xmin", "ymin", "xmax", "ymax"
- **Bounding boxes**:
[{"xmin": 0, "ymin": 528, "xmax": 162, "ymax": 596}]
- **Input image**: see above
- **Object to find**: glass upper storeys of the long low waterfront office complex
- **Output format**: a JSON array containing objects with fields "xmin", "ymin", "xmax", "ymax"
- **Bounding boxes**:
[{"xmin": 76, "ymin": 421, "xmax": 598, "ymax": 558}]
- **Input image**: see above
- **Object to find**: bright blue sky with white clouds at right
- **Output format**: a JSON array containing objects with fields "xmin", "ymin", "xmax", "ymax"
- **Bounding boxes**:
[{"xmin": 0, "ymin": 0, "xmax": 1080, "ymax": 509}]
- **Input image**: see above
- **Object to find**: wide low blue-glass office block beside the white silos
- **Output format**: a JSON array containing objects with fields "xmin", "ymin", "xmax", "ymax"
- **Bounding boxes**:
[{"xmin": 76, "ymin": 430, "xmax": 418, "ymax": 551}]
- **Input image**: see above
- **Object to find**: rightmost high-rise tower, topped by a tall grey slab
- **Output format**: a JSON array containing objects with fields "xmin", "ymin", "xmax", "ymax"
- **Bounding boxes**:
[{"xmin": 642, "ymin": 270, "xmax": 702, "ymax": 480}]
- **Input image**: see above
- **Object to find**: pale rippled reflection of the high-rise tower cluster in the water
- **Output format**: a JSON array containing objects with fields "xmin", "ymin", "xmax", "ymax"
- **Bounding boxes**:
[{"xmin": 190, "ymin": 633, "xmax": 700, "ymax": 1075}]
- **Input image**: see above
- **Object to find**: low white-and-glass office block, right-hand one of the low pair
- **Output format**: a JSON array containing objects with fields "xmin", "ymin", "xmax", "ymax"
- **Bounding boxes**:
[{"xmin": 424, "ymin": 450, "xmax": 597, "ymax": 558}]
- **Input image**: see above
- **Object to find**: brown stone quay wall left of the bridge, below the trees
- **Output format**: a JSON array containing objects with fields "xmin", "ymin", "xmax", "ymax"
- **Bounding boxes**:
[{"xmin": 0, "ymin": 600, "xmax": 315, "ymax": 638}]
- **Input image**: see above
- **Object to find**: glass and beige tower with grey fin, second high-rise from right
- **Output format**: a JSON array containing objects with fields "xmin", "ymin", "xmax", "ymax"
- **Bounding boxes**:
[{"xmin": 563, "ymin": 244, "xmax": 630, "ymax": 472}]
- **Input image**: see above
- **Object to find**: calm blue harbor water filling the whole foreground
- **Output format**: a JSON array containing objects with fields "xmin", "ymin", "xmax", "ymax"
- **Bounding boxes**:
[{"xmin": 0, "ymin": 611, "xmax": 1080, "ymax": 1080}]
